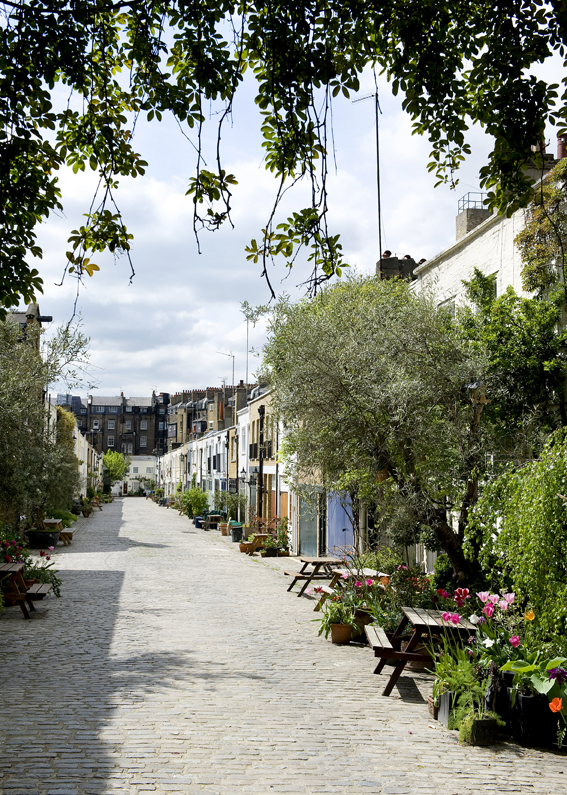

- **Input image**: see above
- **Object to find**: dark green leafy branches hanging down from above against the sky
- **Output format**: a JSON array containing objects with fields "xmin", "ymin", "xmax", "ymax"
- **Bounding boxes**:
[{"xmin": 0, "ymin": 0, "xmax": 567, "ymax": 306}]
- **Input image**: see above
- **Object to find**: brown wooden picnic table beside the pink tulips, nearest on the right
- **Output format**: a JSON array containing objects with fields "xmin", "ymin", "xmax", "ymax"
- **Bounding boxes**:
[{"xmin": 364, "ymin": 607, "xmax": 476, "ymax": 696}]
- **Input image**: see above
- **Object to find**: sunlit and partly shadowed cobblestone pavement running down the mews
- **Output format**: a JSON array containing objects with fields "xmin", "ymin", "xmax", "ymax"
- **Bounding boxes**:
[{"xmin": 0, "ymin": 498, "xmax": 567, "ymax": 795}]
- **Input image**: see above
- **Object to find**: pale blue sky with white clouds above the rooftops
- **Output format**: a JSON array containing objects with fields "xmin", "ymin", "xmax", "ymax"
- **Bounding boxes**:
[{"xmin": 39, "ymin": 57, "xmax": 558, "ymax": 395}]
